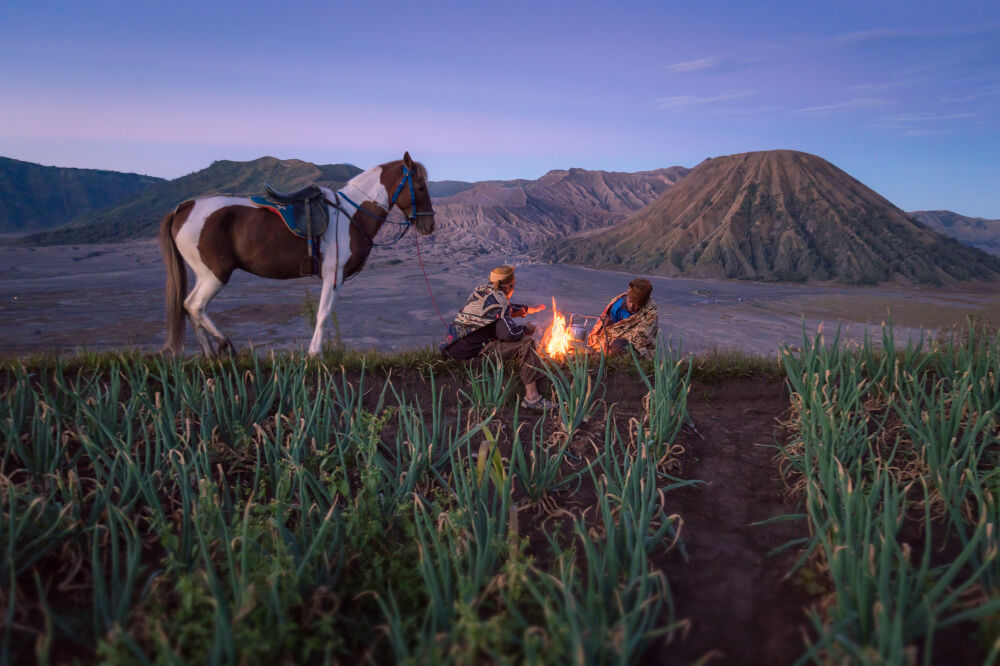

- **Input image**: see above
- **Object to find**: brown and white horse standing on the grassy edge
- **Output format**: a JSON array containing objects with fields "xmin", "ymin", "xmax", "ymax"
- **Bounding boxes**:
[{"xmin": 160, "ymin": 153, "xmax": 434, "ymax": 356}]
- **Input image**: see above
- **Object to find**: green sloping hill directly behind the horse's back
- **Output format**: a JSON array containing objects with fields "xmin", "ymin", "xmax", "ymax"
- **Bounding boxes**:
[{"xmin": 25, "ymin": 157, "xmax": 361, "ymax": 245}]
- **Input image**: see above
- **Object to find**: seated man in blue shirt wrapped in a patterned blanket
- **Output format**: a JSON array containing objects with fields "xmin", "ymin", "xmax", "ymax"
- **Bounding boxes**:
[{"xmin": 587, "ymin": 278, "xmax": 660, "ymax": 359}]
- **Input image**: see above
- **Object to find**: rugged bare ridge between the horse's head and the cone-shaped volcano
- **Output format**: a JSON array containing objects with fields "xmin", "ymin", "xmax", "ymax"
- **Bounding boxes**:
[{"xmin": 432, "ymin": 166, "xmax": 690, "ymax": 253}]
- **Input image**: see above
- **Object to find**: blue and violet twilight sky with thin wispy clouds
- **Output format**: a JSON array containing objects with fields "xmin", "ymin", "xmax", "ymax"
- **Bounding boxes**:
[{"xmin": 0, "ymin": 0, "xmax": 1000, "ymax": 219}]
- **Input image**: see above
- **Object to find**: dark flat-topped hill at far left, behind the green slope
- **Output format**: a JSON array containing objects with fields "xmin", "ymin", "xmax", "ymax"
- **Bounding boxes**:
[{"xmin": 0, "ymin": 157, "xmax": 164, "ymax": 233}]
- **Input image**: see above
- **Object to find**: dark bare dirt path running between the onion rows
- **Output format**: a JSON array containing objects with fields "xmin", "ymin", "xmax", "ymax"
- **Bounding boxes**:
[{"xmin": 645, "ymin": 380, "xmax": 812, "ymax": 666}]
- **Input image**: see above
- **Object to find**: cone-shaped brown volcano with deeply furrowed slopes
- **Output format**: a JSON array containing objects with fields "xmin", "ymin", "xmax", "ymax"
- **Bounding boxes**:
[{"xmin": 537, "ymin": 150, "xmax": 1000, "ymax": 284}]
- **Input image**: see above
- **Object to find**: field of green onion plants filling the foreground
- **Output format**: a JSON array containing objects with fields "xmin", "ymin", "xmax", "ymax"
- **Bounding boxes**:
[{"xmin": 0, "ymin": 328, "xmax": 1000, "ymax": 664}]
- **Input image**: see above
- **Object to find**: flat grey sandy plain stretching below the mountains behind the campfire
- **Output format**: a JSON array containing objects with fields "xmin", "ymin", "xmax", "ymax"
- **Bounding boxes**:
[{"xmin": 0, "ymin": 239, "xmax": 1000, "ymax": 355}]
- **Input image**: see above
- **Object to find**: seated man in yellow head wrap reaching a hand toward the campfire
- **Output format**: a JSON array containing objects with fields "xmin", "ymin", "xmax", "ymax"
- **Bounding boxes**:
[{"xmin": 440, "ymin": 266, "xmax": 555, "ymax": 409}]
